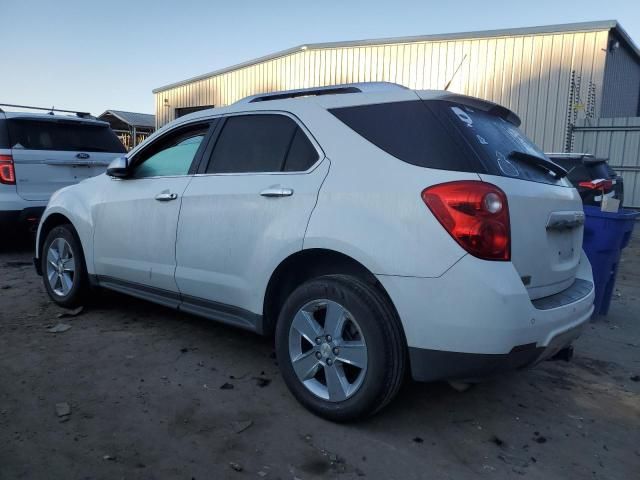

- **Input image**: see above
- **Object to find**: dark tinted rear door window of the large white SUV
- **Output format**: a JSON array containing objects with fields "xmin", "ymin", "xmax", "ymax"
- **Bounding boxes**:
[{"xmin": 207, "ymin": 114, "xmax": 318, "ymax": 173}]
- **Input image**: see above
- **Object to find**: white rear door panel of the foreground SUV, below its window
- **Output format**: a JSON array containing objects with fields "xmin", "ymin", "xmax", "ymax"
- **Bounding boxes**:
[{"xmin": 176, "ymin": 159, "xmax": 330, "ymax": 314}]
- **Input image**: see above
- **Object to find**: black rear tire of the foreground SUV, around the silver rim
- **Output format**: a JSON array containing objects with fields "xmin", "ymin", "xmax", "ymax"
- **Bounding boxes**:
[{"xmin": 276, "ymin": 275, "xmax": 407, "ymax": 422}]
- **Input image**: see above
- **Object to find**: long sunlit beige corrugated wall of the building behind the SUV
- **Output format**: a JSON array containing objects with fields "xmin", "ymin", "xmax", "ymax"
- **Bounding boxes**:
[{"xmin": 156, "ymin": 30, "xmax": 609, "ymax": 151}]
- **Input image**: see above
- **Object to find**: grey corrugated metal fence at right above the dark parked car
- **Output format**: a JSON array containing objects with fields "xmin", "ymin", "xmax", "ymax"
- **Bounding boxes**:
[{"xmin": 574, "ymin": 117, "xmax": 640, "ymax": 208}]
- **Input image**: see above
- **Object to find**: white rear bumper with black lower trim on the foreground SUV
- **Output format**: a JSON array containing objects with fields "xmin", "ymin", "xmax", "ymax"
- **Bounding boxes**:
[{"xmin": 378, "ymin": 252, "xmax": 594, "ymax": 381}]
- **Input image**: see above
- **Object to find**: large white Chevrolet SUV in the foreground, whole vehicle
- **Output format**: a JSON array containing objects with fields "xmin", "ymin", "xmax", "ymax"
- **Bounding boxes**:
[{"xmin": 36, "ymin": 84, "xmax": 593, "ymax": 421}]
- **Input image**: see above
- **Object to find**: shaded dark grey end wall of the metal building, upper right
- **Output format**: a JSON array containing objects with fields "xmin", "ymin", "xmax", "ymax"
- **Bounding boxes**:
[{"xmin": 601, "ymin": 36, "xmax": 640, "ymax": 117}]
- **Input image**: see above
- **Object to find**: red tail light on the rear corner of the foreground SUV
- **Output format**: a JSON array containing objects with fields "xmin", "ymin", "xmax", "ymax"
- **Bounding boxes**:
[{"xmin": 422, "ymin": 180, "xmax": 511, "ymax": 260}]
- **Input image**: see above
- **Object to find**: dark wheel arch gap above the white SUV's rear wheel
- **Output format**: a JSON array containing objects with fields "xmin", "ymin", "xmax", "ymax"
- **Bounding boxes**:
[{"xmin": 262, "ymin": 248, "xmax": 406, "ymax": 342}]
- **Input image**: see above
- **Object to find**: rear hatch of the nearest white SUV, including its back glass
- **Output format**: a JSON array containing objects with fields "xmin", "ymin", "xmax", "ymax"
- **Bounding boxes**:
[{"xmin": 429, "ymin": 99, "xmax": 584, "ymax": 299}]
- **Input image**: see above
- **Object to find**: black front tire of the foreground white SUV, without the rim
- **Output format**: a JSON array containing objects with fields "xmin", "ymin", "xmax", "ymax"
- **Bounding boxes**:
[{"xmin": 40, "ymin": 224, "xmax": 89, "ymax": 308}]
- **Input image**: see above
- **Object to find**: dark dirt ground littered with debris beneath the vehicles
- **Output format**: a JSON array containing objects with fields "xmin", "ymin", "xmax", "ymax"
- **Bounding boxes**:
[{"xmin": 0, "ymin": 228, "xmax": 640, "ymax": 480}]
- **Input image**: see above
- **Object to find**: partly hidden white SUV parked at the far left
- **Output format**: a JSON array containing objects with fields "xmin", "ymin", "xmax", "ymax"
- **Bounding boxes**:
[{"xmin": 0, "ymin": 104, "xmax": 126, "ymax": 231}]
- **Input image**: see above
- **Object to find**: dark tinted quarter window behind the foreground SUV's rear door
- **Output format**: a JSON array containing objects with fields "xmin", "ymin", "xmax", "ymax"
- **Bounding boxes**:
[{"xmin": 330, "ymin": 100, "xmax": 482, "ymax": 172}]
